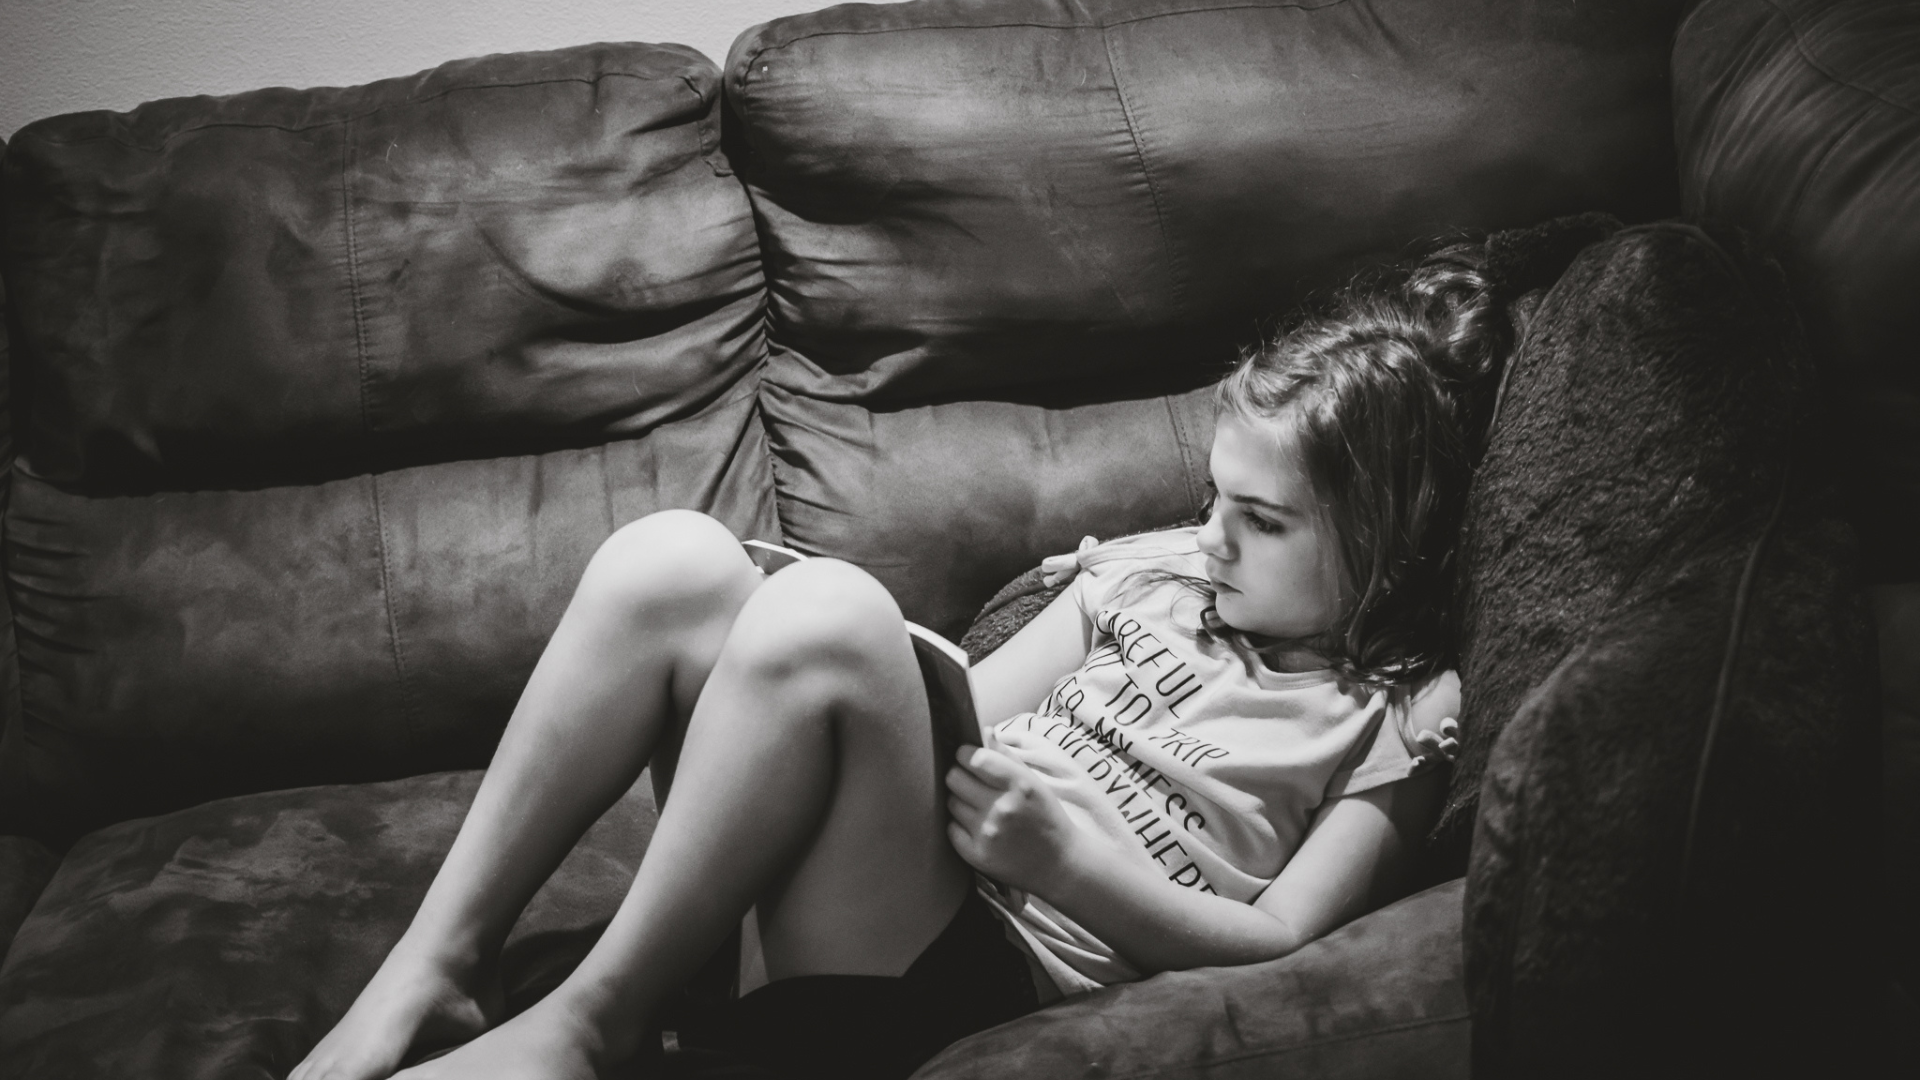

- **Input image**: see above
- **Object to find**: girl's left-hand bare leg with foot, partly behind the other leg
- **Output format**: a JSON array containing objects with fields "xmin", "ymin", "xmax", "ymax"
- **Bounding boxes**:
[{"xmin": 292, "ymin": 511, "xmax": 760, "ymax": 1080}]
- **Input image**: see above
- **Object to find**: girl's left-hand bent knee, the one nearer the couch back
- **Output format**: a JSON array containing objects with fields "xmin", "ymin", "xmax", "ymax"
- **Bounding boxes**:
[{"xmin": 580, "ymin": 509, "xmax": 758, "ymax": 617}]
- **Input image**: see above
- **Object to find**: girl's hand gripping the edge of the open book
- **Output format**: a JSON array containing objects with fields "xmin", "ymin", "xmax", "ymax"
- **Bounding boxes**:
[{"xmin": 947, "ymin": 746, "xmax": 1077, "ymax": 896}]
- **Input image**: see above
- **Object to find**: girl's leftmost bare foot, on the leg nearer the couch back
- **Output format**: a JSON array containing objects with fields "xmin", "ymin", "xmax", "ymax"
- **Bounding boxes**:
[{"xmin": 286, "ymin": 945, "xmax": 501, "ymax": 1080}]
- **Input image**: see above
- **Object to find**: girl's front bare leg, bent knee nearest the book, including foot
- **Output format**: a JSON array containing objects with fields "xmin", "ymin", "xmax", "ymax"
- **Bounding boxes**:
[{"xmin": 387, "ymin": 561, "xmax": 970, "ymax": 1080}]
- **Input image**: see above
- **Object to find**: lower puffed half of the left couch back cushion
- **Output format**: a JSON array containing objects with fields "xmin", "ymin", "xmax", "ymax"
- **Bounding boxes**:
[{"xmin": 4, "ymin": 386, "xmax": 778, "ymax": 838}]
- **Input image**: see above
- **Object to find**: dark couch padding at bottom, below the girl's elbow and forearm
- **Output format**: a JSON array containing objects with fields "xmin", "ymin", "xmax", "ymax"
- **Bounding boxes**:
[{"xmin": 916, "ymin": 880, "xmax": 1469, "ymax": 1080}]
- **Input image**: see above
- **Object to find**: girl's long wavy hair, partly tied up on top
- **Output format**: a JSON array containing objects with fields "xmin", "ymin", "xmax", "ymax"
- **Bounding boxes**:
[{"xmin": 1159, "ymin": 244, "xmax": 1513, "ymax": 686}]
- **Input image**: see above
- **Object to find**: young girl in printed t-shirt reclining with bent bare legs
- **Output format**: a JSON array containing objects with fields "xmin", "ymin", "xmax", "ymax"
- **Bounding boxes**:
[{"xmin": 292, "ymin": 250, "xmax": 1482, "ymax": 1080}]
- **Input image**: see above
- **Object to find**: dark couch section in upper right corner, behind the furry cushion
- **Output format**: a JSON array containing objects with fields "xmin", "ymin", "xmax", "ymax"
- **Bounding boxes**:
[{"xmin": 1672, "ymin": 0, "xmax": 1920, "ymax": 580}]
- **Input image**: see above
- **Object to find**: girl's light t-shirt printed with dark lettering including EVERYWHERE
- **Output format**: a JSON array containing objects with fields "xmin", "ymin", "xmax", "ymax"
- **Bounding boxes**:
[{"xmin": 981, "ymin": 528, "xmax": 1417, "ymax": 994}]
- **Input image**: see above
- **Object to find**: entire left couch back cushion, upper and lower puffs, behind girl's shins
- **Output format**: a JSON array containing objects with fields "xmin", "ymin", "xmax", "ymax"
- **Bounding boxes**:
[{"xmin": 0, "ymin": 44, "xmax": 778, "ymax": 832}]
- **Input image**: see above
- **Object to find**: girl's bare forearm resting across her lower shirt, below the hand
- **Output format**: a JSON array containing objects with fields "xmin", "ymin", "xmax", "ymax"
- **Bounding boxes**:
[{"xmin": 1033, "ymin": 826, "xmax": 1308, "ymax": 974}]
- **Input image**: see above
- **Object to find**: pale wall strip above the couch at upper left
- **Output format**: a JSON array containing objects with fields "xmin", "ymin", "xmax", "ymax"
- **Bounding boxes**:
[{"xmin": 0, "ymin": 0, "xmax": 871, "ymax": 138}]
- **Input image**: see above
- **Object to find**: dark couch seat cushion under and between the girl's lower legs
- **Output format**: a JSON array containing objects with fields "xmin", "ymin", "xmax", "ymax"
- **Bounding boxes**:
[{"xmin": 0, "ymin": 773, "xmax": 655, "ymax": 1080}]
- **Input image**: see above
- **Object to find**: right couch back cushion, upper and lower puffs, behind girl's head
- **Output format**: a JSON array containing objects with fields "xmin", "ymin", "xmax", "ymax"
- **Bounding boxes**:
[{"xmin": 726, "ymin": 0, "xmax": 1674, "ymax": 628}]
